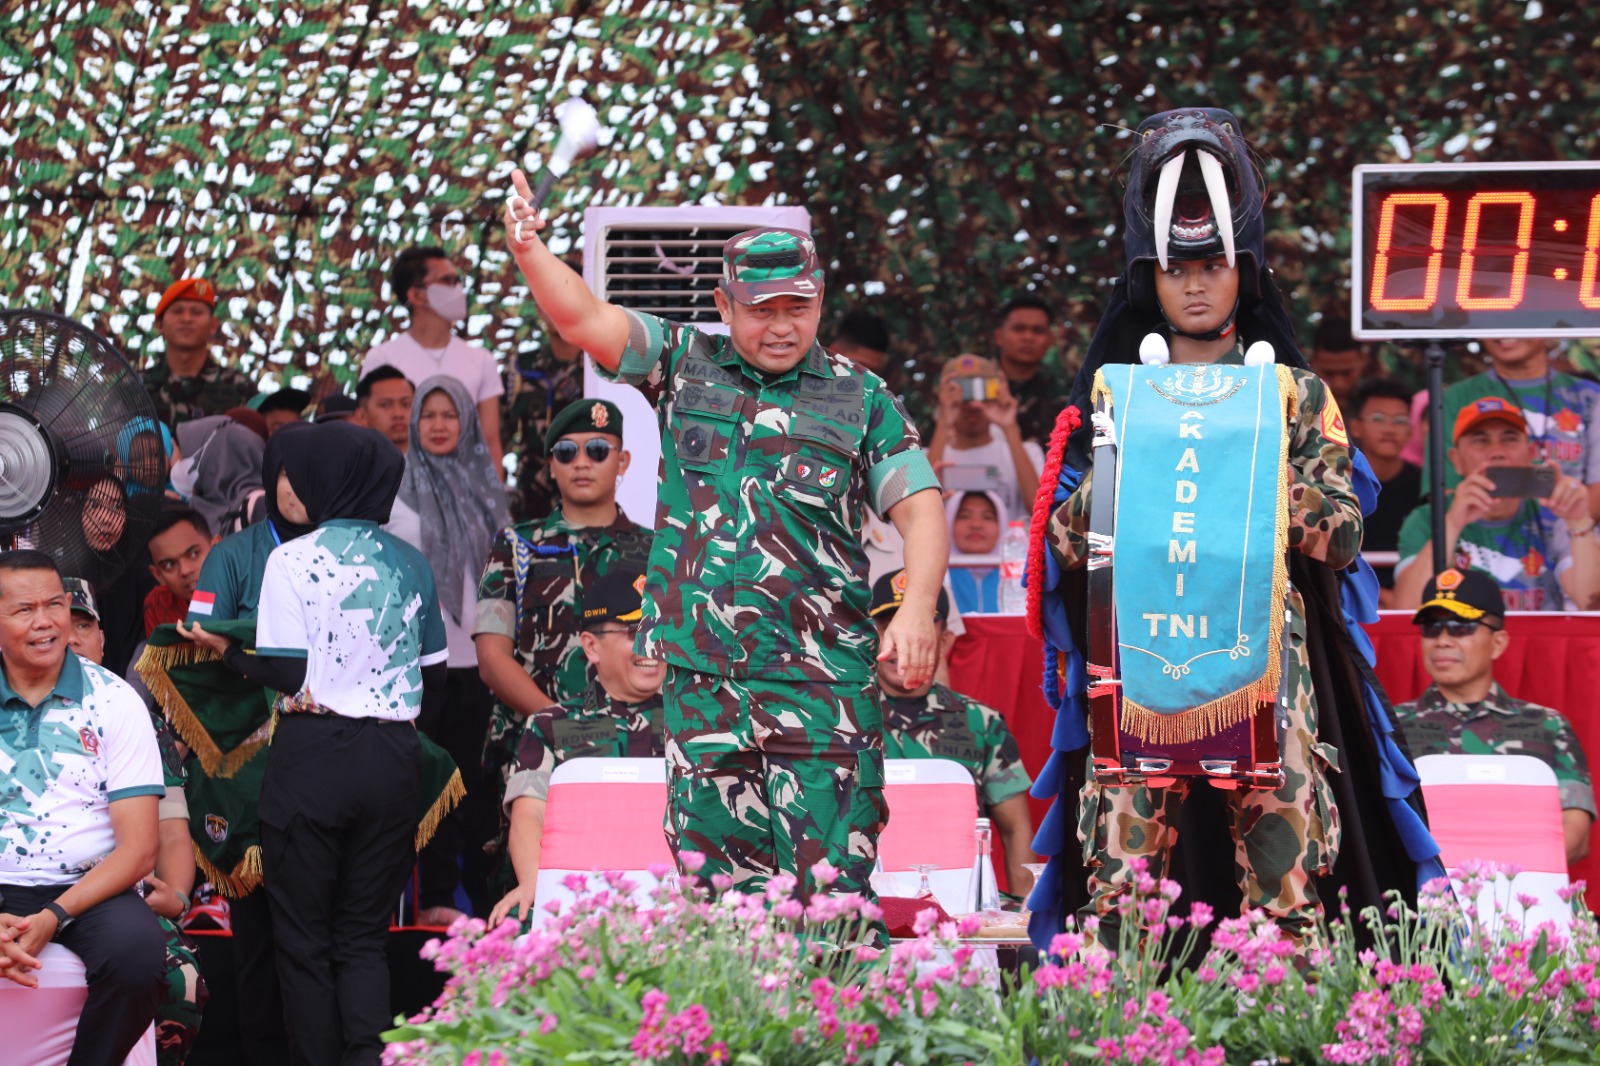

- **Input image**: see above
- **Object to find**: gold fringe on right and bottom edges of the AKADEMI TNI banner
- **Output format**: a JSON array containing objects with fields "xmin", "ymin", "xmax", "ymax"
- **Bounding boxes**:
[{"xmin": 1096, "ymin": 363, "xmax": 1299, "ymax": 744}]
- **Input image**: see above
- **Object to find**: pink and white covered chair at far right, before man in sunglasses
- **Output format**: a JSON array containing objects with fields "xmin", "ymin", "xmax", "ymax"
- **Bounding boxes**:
[{"xmin": 1416, "ymin": 745, "xmax": 1573, "ymax": 928}]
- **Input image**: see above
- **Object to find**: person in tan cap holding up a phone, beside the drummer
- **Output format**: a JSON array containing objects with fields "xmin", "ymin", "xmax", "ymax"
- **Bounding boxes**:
[{"xmin": 928, "ymin": 355, "xmax": 1045, "ymax": 514}]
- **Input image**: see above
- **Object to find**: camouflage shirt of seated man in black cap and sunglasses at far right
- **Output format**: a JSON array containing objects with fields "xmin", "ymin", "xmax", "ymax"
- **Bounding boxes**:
[{"xmin": 1395, "ymin": 685, "xmax": 1595, "ymax": 818}]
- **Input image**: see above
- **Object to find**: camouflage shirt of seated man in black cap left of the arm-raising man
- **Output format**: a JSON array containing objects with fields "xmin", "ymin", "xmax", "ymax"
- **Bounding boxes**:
[{"xmin": 502, "ymin": 682, "xmax": 666, "ymax": 813}]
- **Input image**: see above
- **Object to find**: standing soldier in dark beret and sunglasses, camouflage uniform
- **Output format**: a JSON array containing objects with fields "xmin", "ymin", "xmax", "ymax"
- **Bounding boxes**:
[{"xmin": 472, "ymin": 393, "xmax": 650, "ymax": 791}]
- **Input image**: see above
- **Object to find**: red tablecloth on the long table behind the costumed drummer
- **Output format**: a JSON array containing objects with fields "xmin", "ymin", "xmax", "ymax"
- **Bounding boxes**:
[{"xmin": 950, "ymin": 611, "xmax": 1600, "ymax": 901}]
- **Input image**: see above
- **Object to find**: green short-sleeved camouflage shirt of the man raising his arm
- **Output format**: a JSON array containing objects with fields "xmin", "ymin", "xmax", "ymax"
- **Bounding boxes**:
[{"xmin": 610, "ymin": 311, "xmax": 939, "ymax": 685}]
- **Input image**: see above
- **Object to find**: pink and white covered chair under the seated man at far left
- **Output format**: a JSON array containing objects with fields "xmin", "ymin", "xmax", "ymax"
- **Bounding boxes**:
[{"xmin": 0, "ymin": 944, "xmax": 155, "ymax": 1066}]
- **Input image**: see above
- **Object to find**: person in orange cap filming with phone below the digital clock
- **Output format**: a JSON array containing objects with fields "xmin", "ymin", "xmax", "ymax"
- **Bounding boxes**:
[{"xmin": 1395, "ymin": 397, "xmax": 1600, "ymax": 611}]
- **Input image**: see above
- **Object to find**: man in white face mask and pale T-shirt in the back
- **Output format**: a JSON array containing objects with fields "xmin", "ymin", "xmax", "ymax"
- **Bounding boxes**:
[{"xmin": 362, "ymin": 246, "xmax": 506, "ymax": 480}]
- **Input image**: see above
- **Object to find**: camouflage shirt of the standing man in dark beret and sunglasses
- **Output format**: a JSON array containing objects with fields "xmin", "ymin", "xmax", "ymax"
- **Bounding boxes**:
[{"xmin": 472, "ymin": 507, "xmax": 650, "ymax": 767}]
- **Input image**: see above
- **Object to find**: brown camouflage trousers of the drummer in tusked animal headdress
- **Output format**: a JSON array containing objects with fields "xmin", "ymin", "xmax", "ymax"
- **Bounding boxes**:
[{"xmin": 1078, "ymin": 634, "xmax": 1341, "ymax": 948}]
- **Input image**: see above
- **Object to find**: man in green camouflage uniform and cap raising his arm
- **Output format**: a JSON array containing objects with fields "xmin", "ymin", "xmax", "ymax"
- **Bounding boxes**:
[{"xmin": 507, "ymin": 173, "xmax": 949, "ymax": 892}]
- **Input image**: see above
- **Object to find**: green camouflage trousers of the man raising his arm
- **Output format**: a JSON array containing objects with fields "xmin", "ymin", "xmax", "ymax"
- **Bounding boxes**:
[{"xmin": 664, "ymin": 666, "xmax": 890, "ymax": 896}]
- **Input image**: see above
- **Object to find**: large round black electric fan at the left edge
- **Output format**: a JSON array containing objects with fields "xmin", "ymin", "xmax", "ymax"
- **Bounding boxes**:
[{"xmin": 0, "ymin": 311, "xmax": 166, "ymax": 587}]
